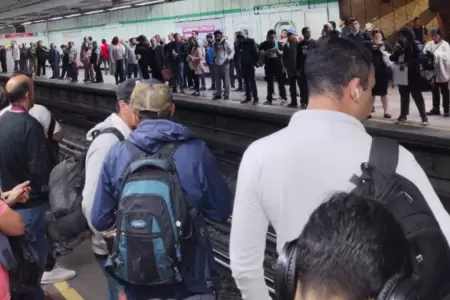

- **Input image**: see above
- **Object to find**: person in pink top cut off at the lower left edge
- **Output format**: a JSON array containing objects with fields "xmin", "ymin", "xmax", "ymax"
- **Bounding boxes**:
[{"xmin": 0, "ymin": 181, "xmax": 30, "ymax": 300}]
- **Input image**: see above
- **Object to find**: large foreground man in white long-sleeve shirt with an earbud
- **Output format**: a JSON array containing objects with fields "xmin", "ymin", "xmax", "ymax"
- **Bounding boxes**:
[{"xmin": 230, "ymin": 38, "xmax": 450, "ymax": 300}]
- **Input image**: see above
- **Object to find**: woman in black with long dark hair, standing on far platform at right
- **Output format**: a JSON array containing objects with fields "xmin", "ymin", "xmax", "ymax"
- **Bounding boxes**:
[{"xmin": 390, "ymin": 27, "xmax": 428, "ymax": 125}]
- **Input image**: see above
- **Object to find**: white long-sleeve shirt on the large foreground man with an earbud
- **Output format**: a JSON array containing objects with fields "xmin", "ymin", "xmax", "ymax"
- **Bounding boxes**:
[{"xmin": 230, "ymin": 110, "xmax": 450, "ymax": 300}]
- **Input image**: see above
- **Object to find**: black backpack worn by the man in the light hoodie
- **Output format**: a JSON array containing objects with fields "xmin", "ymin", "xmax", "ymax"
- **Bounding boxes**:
[{"xmin": 46, "ymin": 127, "xmax": 125, "ymax": 255}]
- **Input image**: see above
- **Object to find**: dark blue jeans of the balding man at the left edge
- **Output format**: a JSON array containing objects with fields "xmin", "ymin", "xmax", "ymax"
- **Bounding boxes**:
[{"xmin": 16, "ymin": 203, "xmax": 50, "ymax": 300}]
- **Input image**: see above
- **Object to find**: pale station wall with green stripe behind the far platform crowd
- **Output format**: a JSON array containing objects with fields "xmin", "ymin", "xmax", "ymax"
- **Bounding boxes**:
[{"xmin": 26, "ymin": 0, "xmax": 339, "ymax": 44}]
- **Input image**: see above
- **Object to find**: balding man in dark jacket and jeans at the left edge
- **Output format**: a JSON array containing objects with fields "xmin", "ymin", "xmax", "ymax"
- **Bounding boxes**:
[{"xmin": 0, "ymin": 75, "xmax": 51, "ymax": 299}]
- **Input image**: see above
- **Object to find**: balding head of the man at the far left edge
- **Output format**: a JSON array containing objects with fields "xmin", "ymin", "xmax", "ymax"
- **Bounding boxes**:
[{"xmin": 6, "ymin": 74, "xmax": 34, "ymax": 108}]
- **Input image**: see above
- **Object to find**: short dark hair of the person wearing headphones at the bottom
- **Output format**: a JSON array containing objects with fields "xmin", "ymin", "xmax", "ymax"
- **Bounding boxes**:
[{"xmin": 296, "ymin": 194, "xmax": 410, "ymax": 300}]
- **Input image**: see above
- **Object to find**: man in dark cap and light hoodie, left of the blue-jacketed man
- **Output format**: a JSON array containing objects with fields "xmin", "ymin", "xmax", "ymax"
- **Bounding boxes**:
[{"xmin": 82, "ymin": 79, "xmax": 138, "ymax": 300}]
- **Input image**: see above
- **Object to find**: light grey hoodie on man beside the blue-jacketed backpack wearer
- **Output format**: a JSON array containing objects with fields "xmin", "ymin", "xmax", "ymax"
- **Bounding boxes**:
[{"xmin": 81, "ymin": 114, "xmax": 131, "ymax": 255}]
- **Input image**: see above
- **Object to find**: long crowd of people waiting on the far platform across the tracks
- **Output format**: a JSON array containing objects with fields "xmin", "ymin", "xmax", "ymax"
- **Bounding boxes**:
[{"xmin": 0, "ymin": 18, "xmax": 450, "ymax": 125}]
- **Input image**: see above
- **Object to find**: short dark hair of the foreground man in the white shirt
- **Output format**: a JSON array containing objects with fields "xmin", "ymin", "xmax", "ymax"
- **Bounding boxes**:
[{"xmin": 305, "ymin": 37, "xmax": 372, "ymax": 98}]
